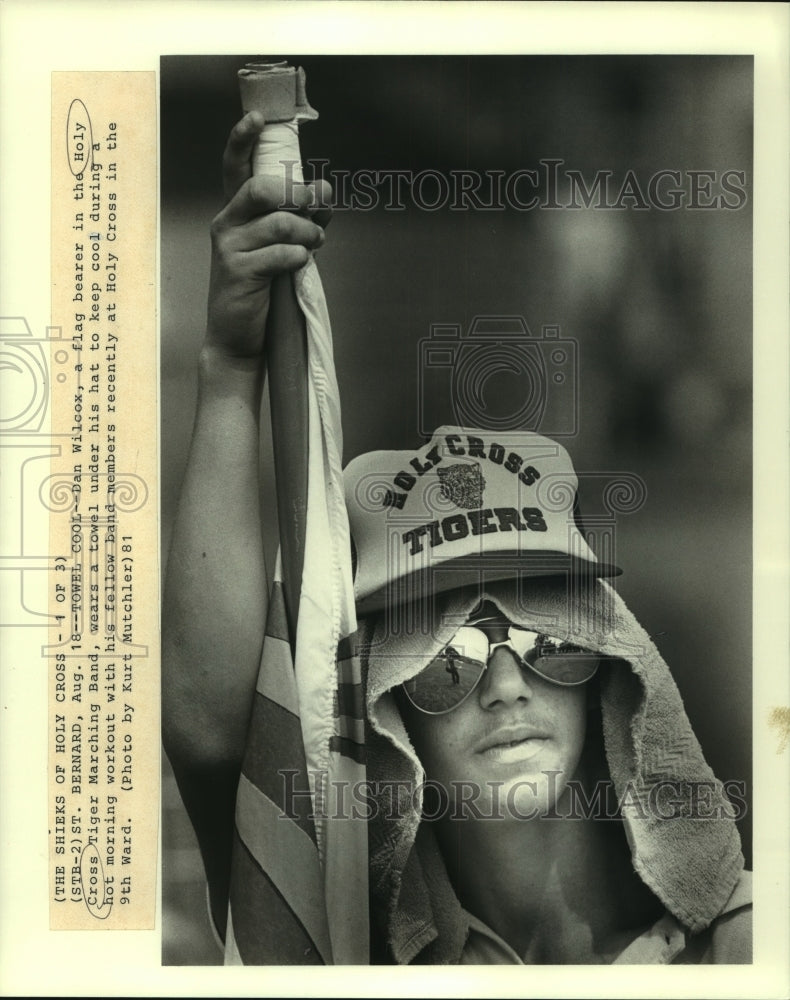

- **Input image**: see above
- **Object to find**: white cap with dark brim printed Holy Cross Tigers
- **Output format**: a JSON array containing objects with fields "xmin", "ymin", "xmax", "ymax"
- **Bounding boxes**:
[{"xmin": 345, "ymin": 426, "xmax": 620, "ymax": 614}]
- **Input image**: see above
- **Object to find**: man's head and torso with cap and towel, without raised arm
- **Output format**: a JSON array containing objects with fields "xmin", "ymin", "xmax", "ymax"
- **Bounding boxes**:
[{"xmin": 346, "ymin": 427, "xmax": 751, "ymax": 964}]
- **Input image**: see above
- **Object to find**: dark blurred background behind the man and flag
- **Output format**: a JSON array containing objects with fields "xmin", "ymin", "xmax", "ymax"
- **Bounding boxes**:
[{"xmin": 160, "ymin": 53, "xmax": 752, "ymax": 964}]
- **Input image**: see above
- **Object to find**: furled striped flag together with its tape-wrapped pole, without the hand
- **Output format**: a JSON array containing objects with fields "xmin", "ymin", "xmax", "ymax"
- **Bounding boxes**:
[{"xmin": 229, "ymin": 63, "xmax": 370, "ymax": 965}]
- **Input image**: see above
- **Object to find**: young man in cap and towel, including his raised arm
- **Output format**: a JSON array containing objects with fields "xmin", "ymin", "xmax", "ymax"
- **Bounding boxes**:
[{"xmin": 163, "ymin": 114, "xmax": 750, "ymax": 964}]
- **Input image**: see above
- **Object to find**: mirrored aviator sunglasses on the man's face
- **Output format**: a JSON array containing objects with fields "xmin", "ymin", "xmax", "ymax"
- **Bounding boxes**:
[{"xmin": 403, "ymin": 616, "xmax": 600, "ymax": 715}]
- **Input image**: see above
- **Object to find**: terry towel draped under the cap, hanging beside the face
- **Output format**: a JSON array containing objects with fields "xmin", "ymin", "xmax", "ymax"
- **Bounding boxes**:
[{"xmin": 361, "ymin": 576, "xmax": 744, "ymax": 961}]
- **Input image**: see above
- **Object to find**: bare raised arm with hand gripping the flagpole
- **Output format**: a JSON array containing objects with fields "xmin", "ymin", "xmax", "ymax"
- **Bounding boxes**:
[{"xmin": 162, "ymin": 113, "xmax": 328, "ymax": 932}]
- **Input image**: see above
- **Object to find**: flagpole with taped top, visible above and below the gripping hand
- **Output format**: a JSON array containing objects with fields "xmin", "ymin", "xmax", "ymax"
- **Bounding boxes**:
[{"xmin": 239, "ymin": 62, "xmax": 318, "ymax": 648}]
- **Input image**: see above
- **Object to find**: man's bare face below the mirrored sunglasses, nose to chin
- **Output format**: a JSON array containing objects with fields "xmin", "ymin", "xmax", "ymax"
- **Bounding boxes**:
[{"xmin": 403, "ymin": 604, "xmax": 587, "ymax": 818}]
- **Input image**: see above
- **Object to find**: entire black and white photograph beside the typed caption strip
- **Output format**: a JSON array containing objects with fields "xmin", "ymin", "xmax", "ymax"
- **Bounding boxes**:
[{"xmin": 160, "ymin": 53, "xmax": 753, "ymax": 965}]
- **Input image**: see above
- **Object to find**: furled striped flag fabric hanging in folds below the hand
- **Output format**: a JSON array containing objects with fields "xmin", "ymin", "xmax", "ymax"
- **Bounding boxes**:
[{"xmin": 225, "ymin": 259, "xmax": 369, "ymax": 965}]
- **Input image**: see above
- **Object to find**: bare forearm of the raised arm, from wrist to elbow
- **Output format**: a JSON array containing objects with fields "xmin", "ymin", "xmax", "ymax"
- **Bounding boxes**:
[{"xmin": 162, "ymin": 348, "xmax": 267, "ymax": 774}]
